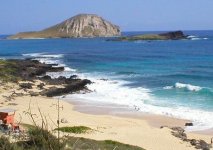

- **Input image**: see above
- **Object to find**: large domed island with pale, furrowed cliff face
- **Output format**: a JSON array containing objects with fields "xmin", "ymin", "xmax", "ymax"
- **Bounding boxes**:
[{"xmin": 9, "ymin": 14, "xmax": 121, "ymax": 39}]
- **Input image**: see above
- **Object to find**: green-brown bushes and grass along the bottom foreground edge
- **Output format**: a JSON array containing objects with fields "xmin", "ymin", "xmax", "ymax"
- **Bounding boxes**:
[{"xmin": 0, "ymin": 127, "xmax": 144, "ymax": 150}]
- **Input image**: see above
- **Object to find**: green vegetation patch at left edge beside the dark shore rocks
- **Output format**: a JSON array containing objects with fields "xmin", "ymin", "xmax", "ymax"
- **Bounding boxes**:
[{"xmin": 0, "ymin": 59, "xmax": 19, "ymax": 82}]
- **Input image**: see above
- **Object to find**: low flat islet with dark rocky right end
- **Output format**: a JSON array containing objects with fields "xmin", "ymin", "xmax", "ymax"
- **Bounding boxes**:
[{"xmin": 108, "ymin": 31, "xmax": 187, "ymax": 41}]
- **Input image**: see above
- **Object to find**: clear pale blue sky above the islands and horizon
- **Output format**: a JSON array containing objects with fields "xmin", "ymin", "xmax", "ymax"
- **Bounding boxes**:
[{"xmin": 0, "ymin": 0, "xmax": 213, "ymax": 34}]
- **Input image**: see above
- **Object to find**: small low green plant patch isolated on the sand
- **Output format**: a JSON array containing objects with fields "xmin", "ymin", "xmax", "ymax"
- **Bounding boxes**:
[{"xmin": 55, "ymin": 126, "xmax": 92, "ymax": 134}]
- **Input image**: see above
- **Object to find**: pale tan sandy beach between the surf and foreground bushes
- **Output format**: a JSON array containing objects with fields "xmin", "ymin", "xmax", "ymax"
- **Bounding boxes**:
[{"xmin": 0, "ymin": 81, "xmax": 212, "ymax": 150}]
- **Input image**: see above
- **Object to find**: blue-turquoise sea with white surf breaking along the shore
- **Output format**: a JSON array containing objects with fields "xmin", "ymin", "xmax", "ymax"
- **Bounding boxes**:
[{"xmin": 0, "ymin": 31, "xmax": 213, "ymax": 130}]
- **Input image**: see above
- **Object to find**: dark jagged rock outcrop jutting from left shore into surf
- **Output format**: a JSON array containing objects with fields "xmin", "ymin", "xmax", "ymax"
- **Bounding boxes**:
[{"xmin": 0, "ymin": 59, "xmax": 92, "ymax": 97}]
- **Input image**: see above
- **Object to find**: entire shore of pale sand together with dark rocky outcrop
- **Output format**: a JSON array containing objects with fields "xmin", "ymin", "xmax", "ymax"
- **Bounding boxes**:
[{"xmin": 0, "ymin": 60, "xmax": 211, "ymax": 150}]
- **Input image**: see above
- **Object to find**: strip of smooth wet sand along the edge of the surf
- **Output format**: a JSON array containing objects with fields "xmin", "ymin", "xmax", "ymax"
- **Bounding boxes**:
[{"xmin": 64, "ymin": 98, "xmax": 213, "ymax": 136}]
